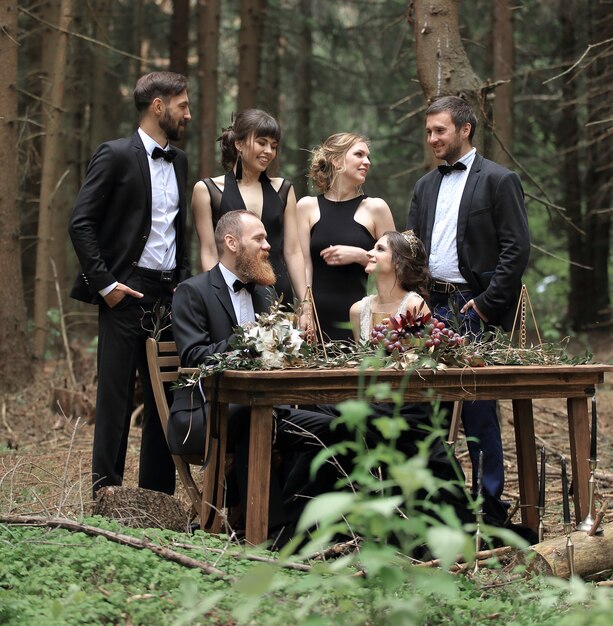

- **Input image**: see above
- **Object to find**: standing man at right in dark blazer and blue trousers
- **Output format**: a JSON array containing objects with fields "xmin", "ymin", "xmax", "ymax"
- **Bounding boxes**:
[{"xmin": 407, "ymin": 96, "xmax": 530, "ymax": 498}]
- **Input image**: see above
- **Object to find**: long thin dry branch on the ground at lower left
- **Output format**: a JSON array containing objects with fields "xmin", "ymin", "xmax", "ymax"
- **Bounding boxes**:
[{"xmin": 0, "ymin": 515, "xmax": 235, "ymax": 582}]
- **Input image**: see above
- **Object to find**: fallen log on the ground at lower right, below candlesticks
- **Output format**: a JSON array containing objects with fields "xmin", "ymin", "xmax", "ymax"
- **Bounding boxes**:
[{"xmin": 528, "ymin": 524, "xmax": 613, "ymax": 579}]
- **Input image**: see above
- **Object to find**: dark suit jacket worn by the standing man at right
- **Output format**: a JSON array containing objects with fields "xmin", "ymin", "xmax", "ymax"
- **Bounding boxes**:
[{"xmin": 407, "ymin": 154, "xmax": 530, "ymax": 330}]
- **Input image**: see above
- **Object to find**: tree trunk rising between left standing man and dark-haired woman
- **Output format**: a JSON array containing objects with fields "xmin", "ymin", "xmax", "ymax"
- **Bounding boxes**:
[{"xmin": 198, "ymin": 0, "xmax": 221, "ymax": 178}]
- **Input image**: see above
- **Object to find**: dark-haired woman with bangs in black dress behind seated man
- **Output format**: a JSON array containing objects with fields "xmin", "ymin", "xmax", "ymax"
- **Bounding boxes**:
[{"xmin": 192, "ymin": 109, "xmax": 306, "ymax": 304}]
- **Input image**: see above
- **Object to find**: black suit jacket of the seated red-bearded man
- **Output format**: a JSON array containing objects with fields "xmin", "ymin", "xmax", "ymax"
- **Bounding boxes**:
[{"xmin": 172, "ymin": 265, "xmax": 270, "ymax": 367}]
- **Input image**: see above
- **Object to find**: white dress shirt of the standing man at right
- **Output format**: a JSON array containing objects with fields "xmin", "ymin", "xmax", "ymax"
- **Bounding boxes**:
[{"xmin": 428, "ymin": 148, "xmax": 477, "ymax": 283}]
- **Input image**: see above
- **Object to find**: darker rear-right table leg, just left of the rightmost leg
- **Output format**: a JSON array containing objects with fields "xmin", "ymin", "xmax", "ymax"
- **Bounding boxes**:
[{"xmin": 513, "ymin": 400, "xmax": 539, "ymax": 531}]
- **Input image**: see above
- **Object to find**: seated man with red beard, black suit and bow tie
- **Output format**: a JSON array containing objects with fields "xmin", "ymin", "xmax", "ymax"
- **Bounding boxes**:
[{"xmin": 170, "ymin": 211, "xmax": 347, "ymax": 528}]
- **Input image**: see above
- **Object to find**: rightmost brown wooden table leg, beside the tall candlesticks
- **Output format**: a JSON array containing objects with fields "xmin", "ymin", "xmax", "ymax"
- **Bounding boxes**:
[{"xmin": 566, "ymin": 397, "xmax": 590, "ymax": 524}]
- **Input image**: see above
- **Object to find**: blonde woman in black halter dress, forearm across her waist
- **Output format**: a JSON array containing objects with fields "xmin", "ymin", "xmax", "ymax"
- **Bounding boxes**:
[{"xmin": 298, "ymin": 133, "xmax": 396, "ymax": 339}]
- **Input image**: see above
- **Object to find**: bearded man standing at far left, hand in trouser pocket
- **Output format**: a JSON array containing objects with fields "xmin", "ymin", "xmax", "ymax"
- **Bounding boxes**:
[{"xmin": 69, "ymin": 72, "xmax": 191, "ymax": 495}]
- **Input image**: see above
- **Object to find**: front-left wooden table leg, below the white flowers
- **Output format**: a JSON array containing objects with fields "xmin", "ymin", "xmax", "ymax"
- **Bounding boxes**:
[{"xmin": 245, "ymin": 406, "xmax": 272, "ymax": 545}]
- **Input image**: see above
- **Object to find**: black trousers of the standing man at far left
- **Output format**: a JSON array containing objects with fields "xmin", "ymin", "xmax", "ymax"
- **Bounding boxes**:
[{"xmin": 92, "ymin": 272, "xmax": 176, "ymax": 495}]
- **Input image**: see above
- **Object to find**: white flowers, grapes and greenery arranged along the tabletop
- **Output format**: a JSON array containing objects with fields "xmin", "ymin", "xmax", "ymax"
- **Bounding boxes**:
[{"xmin": 186, "ymin": 302, "xmax": 590, "ymax": 383}]
